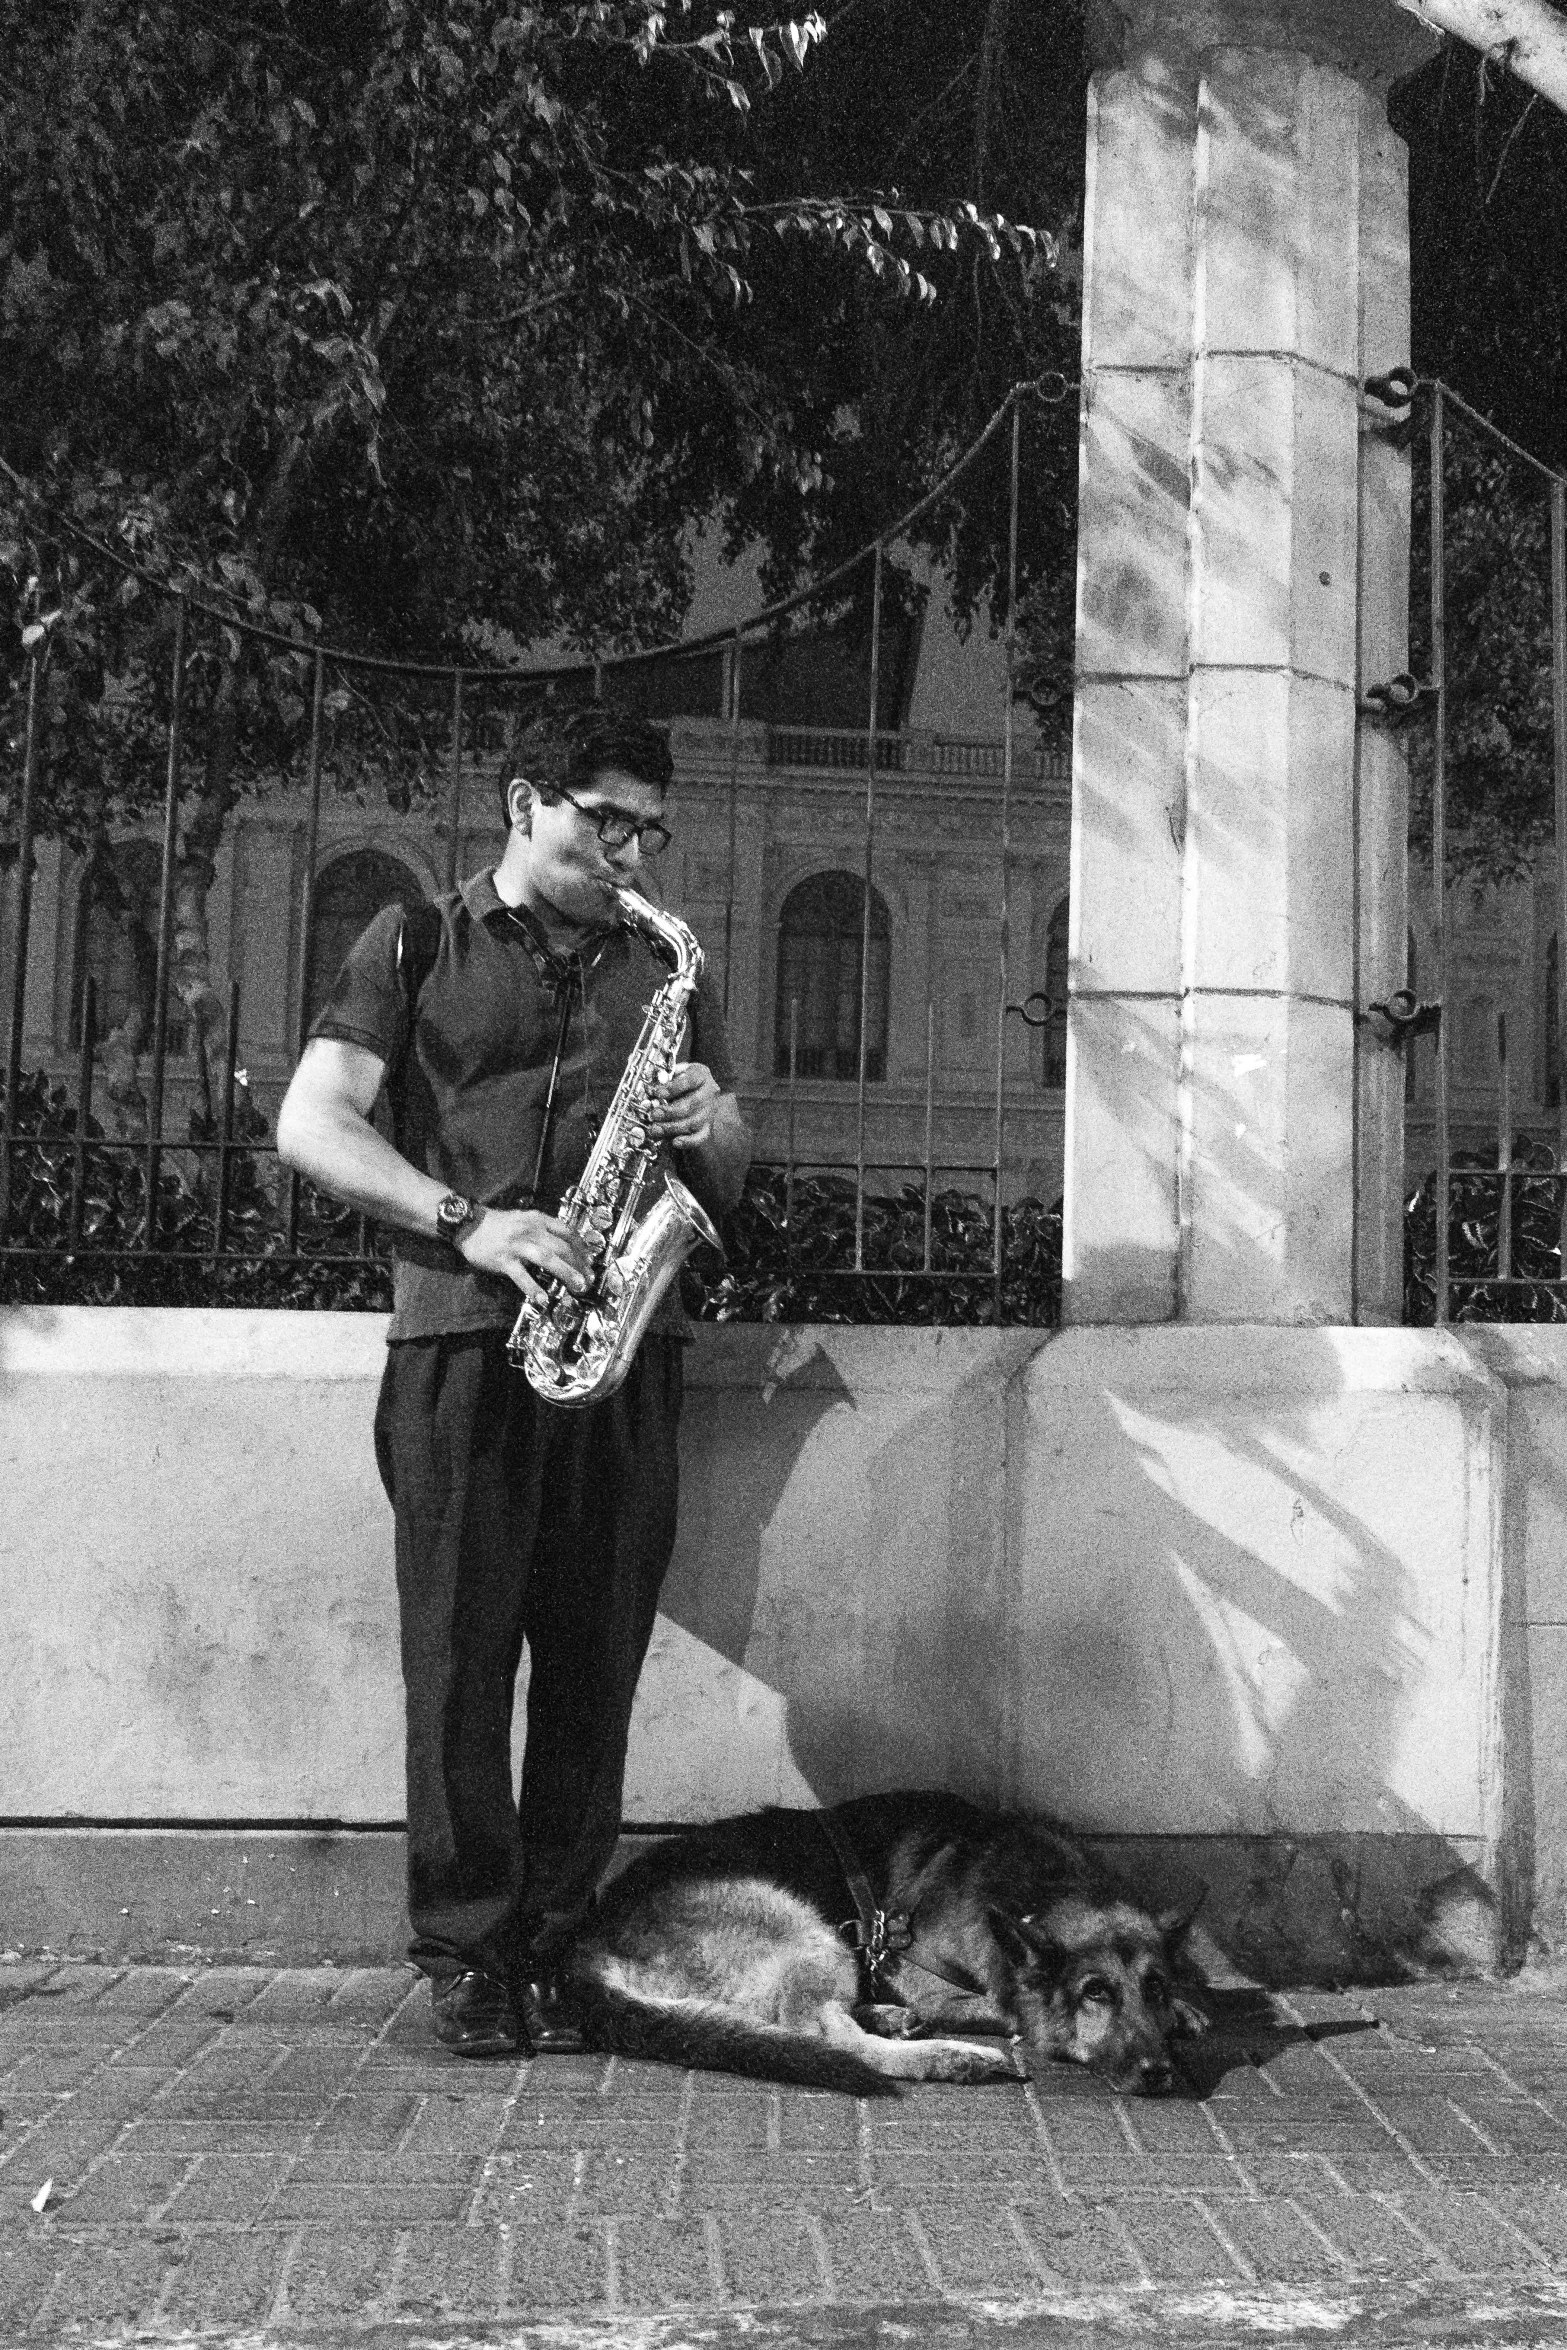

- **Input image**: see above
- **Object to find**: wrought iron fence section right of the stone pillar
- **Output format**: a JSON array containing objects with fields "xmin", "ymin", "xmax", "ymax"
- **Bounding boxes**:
[{"xmin": 1363, "ymin": 374, "xmax": 1567, "ymax": 1323}]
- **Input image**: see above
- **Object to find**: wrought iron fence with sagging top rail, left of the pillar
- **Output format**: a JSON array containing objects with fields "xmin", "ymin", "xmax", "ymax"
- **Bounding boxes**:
[{"xmin": 0, "ymin": 385, "xmax": 1069, "ymax": 1321}]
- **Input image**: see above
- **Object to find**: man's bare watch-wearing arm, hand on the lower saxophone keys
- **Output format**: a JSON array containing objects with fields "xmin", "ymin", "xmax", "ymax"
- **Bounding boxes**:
[{"xmin": 277, "ymin": 1036, "xmax": 587, "ymax": 1302}]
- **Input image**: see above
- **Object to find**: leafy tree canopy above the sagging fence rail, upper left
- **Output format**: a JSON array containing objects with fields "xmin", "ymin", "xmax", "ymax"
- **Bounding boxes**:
[{"xmin": 0, "ymin": 0, "xmax": 1052, "ymax": 839}]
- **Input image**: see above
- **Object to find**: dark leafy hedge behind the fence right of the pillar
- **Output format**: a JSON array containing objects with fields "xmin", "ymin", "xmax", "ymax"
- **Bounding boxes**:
[{"xmin": 1405, "ymin": 1135, "xmax": 1567, "ymax": 1323}]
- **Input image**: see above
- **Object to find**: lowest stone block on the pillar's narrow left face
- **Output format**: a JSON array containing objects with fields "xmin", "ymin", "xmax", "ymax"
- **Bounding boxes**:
[{"xmin": 1062, "ymin": 994, "xmax": 1179, "ymax": 1323}]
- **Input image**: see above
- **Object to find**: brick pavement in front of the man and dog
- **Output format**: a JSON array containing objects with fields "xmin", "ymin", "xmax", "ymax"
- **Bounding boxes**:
[{"xmin": 0, "ymin": 1962, "xmax": 1567, "ymax": 2350}]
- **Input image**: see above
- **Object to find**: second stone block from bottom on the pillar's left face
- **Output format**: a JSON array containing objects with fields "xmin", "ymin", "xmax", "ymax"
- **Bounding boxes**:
[{"xmin": 1069, "ymin": 679, "xmax": 1186, "ymax": 996}]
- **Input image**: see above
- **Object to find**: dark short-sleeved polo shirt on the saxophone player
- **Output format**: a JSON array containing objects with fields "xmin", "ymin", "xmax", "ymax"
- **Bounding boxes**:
[{"xmin": 310, "ymin": 874, "xmax": 733, "ymax": 1342}]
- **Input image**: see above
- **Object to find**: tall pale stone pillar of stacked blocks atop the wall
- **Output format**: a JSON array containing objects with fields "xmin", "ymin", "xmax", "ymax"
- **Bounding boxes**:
[{"xmin": 1064, "ymin": 0, "xmax": 1428, "ymax": 1323}]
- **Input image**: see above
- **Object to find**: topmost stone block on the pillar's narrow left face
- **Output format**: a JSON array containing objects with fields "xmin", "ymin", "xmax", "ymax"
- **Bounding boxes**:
[{"xmin": 1083, "ymin": 56, "xmax": 1196, "ymax": 369}]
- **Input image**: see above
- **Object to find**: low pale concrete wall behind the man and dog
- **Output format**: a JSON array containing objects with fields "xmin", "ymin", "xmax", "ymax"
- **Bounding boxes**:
[{"xmin": 0, "ymin": 1309, "xmax": 1567, "ymax": 1972}]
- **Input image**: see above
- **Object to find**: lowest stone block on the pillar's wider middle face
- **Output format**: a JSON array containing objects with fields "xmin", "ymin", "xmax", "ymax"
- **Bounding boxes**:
[{"xmin": 1182, "ymin": 994, "xmax": 1356, "ymax": 1325}]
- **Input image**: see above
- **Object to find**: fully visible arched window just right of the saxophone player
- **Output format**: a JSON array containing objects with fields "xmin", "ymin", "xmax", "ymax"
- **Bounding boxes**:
[{"xmin": 773, "ymin": 872, "xmax": 890, "ymax": 1081}]
